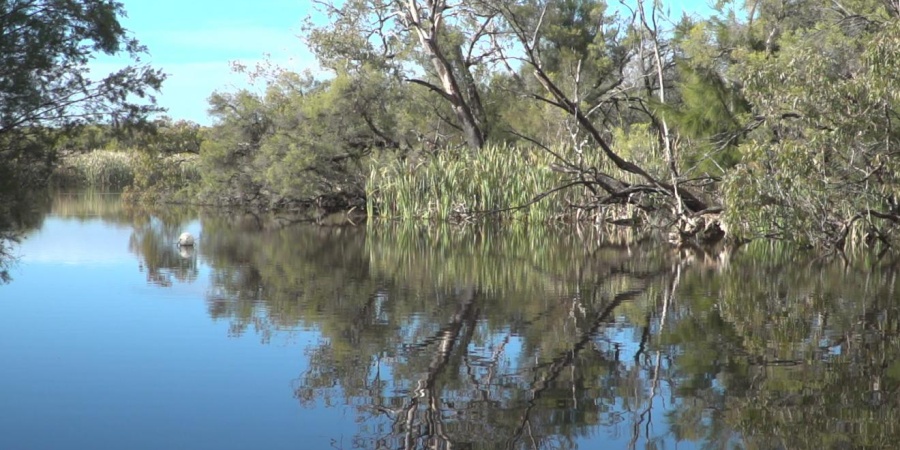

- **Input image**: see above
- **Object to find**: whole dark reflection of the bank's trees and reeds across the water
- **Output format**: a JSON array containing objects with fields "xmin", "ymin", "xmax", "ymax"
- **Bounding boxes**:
[{"xmin": 7, "ymin": 192, "xmax": 900, "ymax": 449}]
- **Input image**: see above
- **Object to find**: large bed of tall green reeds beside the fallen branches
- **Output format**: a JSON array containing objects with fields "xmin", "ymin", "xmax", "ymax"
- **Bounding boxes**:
[{"xmin": 366, "ymin": 145, "xmax": 604, "ymax": 222}]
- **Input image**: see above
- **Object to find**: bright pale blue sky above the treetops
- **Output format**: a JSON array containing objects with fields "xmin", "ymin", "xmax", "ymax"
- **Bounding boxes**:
[{"xmin": 91, "ymin": 0, "xmax": 709, "ymax": 125}]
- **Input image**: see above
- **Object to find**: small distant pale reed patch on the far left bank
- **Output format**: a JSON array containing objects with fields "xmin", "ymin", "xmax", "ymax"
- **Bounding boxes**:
[{"xmin": 52, "ymin": 150, "xmax": 135, "ymax": 189}]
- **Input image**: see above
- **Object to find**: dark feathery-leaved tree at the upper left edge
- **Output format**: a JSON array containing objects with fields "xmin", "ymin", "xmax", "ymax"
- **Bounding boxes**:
[{"xmin": 0, "ymin": 0, "xmax": 165, "ymax": 178}]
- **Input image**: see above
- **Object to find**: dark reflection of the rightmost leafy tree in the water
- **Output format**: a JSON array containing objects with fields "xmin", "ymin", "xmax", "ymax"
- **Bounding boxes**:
[{"xmin": 670, "ymin": 247, "xmax": 900, "ymax": 448}]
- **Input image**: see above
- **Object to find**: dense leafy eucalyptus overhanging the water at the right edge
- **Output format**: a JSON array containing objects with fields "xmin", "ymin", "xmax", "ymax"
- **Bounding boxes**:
[{"xmin": 725, "ymin": 0, "xmax": 900, "ymax": 248}]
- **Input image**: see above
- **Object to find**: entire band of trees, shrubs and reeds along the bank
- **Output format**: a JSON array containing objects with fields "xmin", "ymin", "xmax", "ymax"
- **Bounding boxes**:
[{"xmin": 0, "ymin": 0, "xmax": 900, "ymax": 253}]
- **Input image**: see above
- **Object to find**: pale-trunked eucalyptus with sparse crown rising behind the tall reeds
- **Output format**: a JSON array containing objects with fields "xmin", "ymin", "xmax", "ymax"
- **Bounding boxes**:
[{"xmin": 307, "ymin": 0, "xmax": 496, "ymax": 150}]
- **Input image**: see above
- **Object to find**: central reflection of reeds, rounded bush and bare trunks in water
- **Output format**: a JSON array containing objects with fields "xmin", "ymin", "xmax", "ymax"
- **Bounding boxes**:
[{"xmin": 202, "ymin": 222, "xmax": 684, "ymax": 448}]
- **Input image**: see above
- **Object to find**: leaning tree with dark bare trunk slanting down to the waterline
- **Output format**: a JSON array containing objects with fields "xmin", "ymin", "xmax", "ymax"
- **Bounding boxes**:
[{"xmin": 486, "ymin": 0, "xmax": 719, "ymax": 239}]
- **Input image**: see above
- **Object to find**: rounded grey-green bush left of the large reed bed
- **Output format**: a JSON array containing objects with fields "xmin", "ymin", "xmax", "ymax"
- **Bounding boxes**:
[{"xmin": 201, "ymin": 62, "xmax": 427, "ymax": 207}]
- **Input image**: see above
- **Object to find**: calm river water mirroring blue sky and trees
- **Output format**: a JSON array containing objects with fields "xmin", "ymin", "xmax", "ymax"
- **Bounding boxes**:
[{"xmin": 0, "ymin": 194, "xmax": 900, "ymax": 450}]
